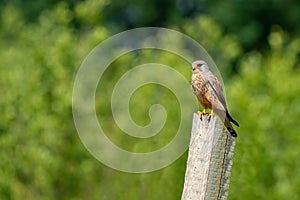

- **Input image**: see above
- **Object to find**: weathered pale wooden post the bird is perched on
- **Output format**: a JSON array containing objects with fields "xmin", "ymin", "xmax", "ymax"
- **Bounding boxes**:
[{"xmin": 181, "ymin": 114, "xmax": 235, "ymax": 200}]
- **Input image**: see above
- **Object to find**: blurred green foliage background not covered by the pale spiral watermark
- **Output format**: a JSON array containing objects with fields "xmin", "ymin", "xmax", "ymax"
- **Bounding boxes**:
[{"xmin": 0, "ymin": 0, "xmax": 300, "ymax": 200}]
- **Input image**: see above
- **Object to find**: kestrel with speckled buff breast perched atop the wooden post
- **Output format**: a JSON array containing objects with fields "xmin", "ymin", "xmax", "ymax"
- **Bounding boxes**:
[{"xmin": 192, "ymin": 60, "xmax": 239, "ymax": 137}]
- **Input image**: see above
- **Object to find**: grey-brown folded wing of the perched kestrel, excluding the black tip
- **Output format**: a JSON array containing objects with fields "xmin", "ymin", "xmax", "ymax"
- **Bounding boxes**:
[{"xmin": 207, "ymin": 72, "xmax": 227, "ymax": 110}]
